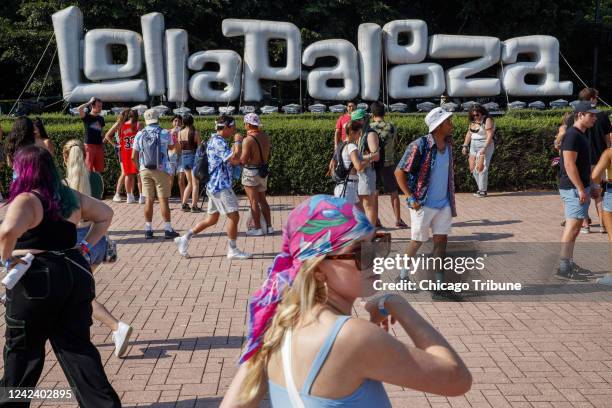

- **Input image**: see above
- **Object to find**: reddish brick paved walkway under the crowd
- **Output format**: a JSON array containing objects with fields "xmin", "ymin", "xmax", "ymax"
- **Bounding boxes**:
[{"xmin": 0, "ymin": 193, "xmax": 612, "ymax": 407}]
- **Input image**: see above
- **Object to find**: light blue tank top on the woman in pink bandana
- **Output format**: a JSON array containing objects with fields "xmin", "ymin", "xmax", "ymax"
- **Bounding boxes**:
[{"xmin": 268, "ymin": 316, "xmax": 391, "ymax": 408}]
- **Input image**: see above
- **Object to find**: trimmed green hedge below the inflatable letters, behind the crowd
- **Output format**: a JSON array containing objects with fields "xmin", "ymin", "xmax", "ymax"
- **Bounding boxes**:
[{"xmin": 0, "ymin": 110, "xmax": 608, "ymax": 194}]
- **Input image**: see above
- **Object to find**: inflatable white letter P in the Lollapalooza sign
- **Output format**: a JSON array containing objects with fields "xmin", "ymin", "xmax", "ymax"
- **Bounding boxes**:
[{"xmin": 222, "ymin": 18, "xmax": 302, "ymax": 101}]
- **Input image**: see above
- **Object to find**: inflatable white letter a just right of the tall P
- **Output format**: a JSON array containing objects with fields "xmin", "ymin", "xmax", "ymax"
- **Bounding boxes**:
[{"xmin": 302, "ymin": 40, "xmax": 359, "ymax": 101}]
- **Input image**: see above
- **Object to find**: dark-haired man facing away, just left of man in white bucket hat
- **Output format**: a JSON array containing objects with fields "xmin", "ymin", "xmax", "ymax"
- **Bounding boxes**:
[{"xmin": 370, "ymin": 101, "xmax": 408, "ymax": 228}]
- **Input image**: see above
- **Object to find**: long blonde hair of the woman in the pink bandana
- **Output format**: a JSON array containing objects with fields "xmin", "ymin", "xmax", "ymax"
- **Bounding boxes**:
[{"xmin": 239, "ymin": 256, "xmax": 327, "ymax": 404}]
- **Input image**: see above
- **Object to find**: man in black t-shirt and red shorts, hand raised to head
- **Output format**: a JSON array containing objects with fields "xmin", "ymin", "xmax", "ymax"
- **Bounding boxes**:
[{"xmin": 78, "ymin": 97, "xmax": 104, "ymax": 173}]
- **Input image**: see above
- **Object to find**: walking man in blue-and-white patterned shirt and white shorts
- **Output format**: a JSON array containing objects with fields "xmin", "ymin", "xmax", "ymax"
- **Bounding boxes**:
[{"xmin": 174, "ymin": 115, "xmax": 252, "ymax": 259}]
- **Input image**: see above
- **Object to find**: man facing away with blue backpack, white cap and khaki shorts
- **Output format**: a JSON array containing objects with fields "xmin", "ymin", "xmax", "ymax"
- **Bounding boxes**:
[{"xmin": 132, "ymin": 109, "xmax": 179, "ymax": 239}]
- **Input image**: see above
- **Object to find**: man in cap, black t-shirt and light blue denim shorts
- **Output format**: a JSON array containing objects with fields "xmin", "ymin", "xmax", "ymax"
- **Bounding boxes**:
[{"xmin": 557, "ymin": 101, "xmax": 598, "ymax": 280}]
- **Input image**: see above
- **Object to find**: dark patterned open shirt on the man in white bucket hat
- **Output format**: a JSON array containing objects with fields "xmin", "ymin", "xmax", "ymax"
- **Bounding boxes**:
[{"xmin": 397, "ymin": 134, "xmax": 457, "ymax": 217}]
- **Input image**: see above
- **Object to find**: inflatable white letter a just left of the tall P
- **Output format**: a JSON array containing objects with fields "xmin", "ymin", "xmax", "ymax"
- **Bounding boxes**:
[{"xmin": 189, "ymin": 50, "xmax": 242, "ymax": 102}]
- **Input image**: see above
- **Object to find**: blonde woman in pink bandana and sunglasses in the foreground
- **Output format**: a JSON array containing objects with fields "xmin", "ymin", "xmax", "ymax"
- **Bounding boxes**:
[{"xmin": 221, "ymin": 195, "xmax": 472, "ymax": 408}]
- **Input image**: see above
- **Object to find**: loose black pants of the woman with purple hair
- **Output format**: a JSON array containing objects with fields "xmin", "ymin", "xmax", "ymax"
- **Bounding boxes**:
[{"xmin": 0, "ymin": 250, "xmax": 121, "ymax": 408}]
